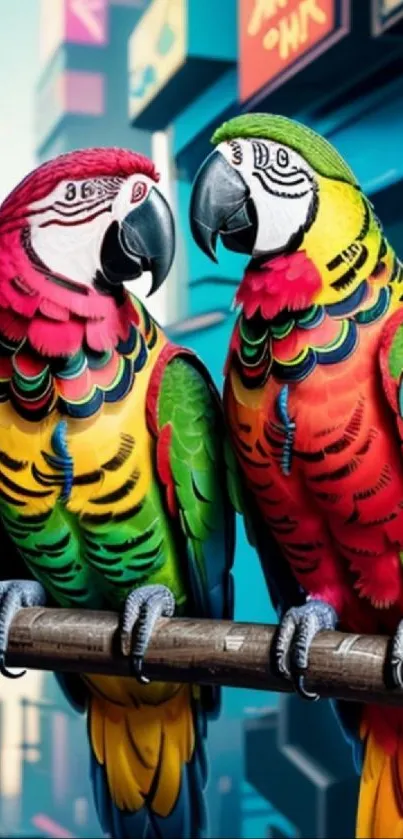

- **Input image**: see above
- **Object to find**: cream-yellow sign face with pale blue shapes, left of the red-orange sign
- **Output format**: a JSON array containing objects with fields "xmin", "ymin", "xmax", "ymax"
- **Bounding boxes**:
[{"xmin": 129, "ymin": 0, "xmax": 187, "ymax": 119}]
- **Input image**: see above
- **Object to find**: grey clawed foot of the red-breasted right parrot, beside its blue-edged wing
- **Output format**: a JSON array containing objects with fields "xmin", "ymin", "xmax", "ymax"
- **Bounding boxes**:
[{"xmin": 274, "ymin": 600, "xmax": 337, "ymax": 702}]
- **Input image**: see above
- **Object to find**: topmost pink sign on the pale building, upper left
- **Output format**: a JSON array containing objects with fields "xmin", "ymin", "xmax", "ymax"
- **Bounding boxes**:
[{"xmin": 40, "ymin": 0, "xmax": 109, "ymax": 67}]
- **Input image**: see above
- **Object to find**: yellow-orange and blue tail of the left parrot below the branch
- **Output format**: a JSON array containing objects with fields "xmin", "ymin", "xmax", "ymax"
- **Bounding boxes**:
[{"xmin": 89, "ymin": 686, "xmax": 207, "ymax": 839}]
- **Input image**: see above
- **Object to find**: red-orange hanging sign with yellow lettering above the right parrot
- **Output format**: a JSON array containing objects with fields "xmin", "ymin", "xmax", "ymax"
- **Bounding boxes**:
[{"xmin": 239, "ymin": 0, "xmax": 350, "ymax": 102}]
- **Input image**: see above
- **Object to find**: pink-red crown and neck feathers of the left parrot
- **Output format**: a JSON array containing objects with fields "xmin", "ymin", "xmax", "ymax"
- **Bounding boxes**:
[{"xmin": 0, "ymin": 148, "xmax": 159, "ymax": 356}]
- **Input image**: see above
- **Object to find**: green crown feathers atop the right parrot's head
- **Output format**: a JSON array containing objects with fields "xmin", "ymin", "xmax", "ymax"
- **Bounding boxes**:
[{"xmin": 212, "ymin": 114, "xmax": 358, "ymax": 186}]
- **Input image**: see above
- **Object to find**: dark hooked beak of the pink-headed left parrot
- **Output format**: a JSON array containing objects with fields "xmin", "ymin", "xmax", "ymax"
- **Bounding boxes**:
[{"xmin": 119, "ymin": 187, "xmax": 175, "ymax": 296}]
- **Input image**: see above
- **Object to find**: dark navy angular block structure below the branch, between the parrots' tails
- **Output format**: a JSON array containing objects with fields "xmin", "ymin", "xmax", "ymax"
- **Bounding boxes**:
[{"xmin": 245, "ymin": 696, "xmax": 358, "ymax": 839}]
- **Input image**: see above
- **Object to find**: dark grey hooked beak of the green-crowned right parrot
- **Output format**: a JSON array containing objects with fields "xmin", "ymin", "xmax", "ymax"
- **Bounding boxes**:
[{"xmin": 190, "ymin": 151, "xmax": 257, "ymax": 262}]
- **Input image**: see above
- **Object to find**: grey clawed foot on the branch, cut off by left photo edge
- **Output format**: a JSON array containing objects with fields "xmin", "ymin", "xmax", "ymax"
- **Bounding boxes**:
[{"xmin": 0, "ymin": 580, "xmax": 47, "ymax": 679}]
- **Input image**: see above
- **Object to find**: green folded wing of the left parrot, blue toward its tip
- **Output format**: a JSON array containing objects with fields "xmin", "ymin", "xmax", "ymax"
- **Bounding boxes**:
[{"xmin": 157, "ymin": 355, "xmax": 235, "ymax": 618}]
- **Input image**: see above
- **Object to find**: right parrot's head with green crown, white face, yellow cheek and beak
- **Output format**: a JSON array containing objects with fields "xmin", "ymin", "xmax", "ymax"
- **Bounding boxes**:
[{"xmin": 191, "ymin": 108, "xmax": 368, "ymax": 282}]
